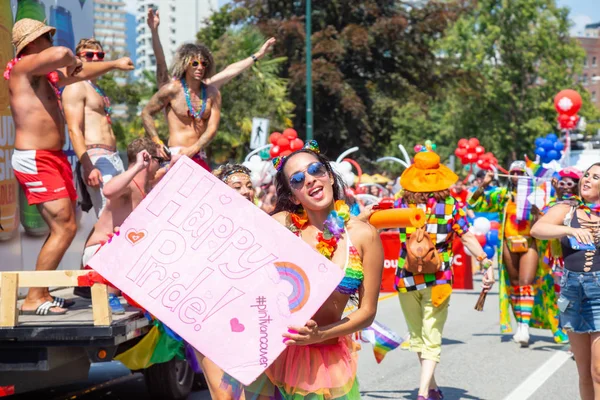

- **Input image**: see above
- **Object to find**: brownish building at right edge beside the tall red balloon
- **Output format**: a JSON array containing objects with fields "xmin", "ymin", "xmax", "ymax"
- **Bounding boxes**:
[{"xmin": 577, "ymin": 23, "xmax": 600, "ymax": 110}]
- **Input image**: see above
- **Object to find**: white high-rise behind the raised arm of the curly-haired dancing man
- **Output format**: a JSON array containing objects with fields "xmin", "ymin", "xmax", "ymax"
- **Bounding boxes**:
[{"xmin": 135, "ymin": 0, "xmax": 218, "ymax": 77}]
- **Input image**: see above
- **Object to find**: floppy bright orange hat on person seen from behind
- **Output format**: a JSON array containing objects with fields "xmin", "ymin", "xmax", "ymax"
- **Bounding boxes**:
[{"xmin": 400, "ymin": 151, "xmax": 458, "ymax": 193}]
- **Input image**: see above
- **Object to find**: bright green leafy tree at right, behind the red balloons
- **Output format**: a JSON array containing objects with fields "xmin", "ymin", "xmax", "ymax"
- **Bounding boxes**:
[{"xmin": 439, "ymin": 0, "xmax": 598, "ymax": 163}]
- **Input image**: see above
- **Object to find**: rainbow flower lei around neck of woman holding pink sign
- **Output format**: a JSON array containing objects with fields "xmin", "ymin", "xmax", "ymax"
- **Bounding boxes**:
[{"xmin": 290, "ymin": 200, "xmax": 350, "ymax": 260}]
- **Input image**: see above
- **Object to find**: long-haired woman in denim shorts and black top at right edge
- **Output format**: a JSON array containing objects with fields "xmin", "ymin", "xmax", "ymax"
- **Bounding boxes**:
[{"xmin": 531, "ymin": 163, "xmax": 600, "ymax": 400}]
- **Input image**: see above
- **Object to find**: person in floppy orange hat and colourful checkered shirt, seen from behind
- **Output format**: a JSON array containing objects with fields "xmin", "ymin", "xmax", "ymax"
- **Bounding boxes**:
[{"xmin": 395, "ymin": 151, "xmax": 494, "ymax": 400}]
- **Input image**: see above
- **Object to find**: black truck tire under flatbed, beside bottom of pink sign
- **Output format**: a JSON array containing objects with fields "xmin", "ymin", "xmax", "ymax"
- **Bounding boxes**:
[{"xmin": 144, "ymin": 359, "xmax": 194, "ymax": 400}]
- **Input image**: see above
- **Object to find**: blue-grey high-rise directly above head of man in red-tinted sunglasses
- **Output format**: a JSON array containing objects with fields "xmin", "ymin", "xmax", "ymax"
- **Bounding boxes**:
[{"xmin": 94, "ymin": 0, "xmax": 129, "ymax": 58}]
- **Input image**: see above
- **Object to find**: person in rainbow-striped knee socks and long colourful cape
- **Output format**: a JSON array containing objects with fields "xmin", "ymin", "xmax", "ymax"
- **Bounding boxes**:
[{"xmin": 468, "ymin": 161, "xmax": 568, "ymax": 347}]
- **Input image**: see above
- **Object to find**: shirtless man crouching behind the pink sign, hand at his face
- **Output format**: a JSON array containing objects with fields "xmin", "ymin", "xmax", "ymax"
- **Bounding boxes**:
[{"xmin": 82, "ymin": 137, "xmax": 164, "ymax": 314}]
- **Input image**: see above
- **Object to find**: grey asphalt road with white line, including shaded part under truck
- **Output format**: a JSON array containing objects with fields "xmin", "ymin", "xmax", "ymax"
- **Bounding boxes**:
[{"xmin": 20, "ymin": 276, "xmax": 579, "ymax": 400}]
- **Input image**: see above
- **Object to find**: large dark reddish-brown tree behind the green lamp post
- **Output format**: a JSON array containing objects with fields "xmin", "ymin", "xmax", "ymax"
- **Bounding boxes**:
[{"xmin": 209, "ymin": 0, "xmax": 463, "ymax": 166}]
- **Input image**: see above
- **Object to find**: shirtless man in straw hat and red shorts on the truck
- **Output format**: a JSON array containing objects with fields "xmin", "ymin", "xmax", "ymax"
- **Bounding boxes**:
[{"xmin": 6, "ymin": 18, "xmax": 133, "ymax": 315}]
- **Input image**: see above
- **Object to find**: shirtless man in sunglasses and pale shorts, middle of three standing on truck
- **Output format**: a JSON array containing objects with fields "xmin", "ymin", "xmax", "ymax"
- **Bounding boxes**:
[{"xmin": 62, "ymin": 39, "xmax": 125, "ymax": 217}]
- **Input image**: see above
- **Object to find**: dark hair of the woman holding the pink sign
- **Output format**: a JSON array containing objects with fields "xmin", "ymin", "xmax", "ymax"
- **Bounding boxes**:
[{"xmin": 271, "ymin": 149, "xmax": 354, "ymax": 215}]
